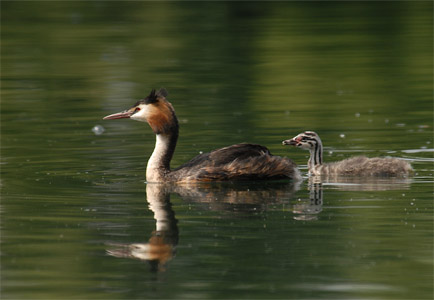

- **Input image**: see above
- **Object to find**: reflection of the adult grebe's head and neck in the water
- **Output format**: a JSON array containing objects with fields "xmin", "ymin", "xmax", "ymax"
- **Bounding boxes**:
[{"xmin": 107, "ymin": 184, "xmax": 179, "ymax": 272}]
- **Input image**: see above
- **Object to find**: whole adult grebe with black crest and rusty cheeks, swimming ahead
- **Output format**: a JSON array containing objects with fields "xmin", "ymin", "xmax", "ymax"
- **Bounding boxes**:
[{"xmin": 104, "ymin": 89, "xmax": 301, "ymax": 182}]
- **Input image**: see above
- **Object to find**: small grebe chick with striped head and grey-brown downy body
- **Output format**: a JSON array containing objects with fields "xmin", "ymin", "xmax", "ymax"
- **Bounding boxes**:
[{"xmin": 282, "ymin": 131, "xmax": 413, "ymax": 177}]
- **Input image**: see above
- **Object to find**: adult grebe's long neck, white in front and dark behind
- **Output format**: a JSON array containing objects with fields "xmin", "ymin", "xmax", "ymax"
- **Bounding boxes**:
[{"xmin": 146, "ymin": 133, "xmax": 178, "ymax": 182}]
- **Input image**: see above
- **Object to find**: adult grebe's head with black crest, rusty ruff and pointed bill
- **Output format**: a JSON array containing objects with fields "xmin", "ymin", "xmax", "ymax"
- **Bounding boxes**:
[{"xmin": 103, "ymin": 89, "xmax": 178, "ymax": 134}]
